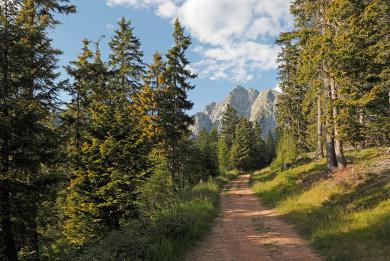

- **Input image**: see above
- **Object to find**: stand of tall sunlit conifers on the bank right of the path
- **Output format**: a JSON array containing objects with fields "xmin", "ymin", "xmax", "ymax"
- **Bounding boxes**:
[{"xmin": 277, "ymin": 0, "xmax": 390, "ymax": 170}]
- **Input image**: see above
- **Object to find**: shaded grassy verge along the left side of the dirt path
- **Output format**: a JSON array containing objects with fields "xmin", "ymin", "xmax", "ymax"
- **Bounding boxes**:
[{"xmin": 71, "ymin": 172, "xmax": 239, "ymax": 261}]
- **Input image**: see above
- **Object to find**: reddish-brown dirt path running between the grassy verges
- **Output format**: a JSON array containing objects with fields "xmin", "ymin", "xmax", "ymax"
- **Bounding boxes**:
[{"xmin": 186, "ymin": 175, "xmax": 321, "ymax": 261}]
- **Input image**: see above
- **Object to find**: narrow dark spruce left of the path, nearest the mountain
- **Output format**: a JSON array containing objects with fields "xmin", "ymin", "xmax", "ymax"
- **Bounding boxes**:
[{"xmin": 160, "ymin": 19, "xmax": 196, "ymax": 189}]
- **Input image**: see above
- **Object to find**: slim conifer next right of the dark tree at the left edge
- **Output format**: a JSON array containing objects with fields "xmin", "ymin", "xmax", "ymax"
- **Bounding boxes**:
[{"xmin": 63, "ymin": 40, "xmax": 102, "ymax": 245}]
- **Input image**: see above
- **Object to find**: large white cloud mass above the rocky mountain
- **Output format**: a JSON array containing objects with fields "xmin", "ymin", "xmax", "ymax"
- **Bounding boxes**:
[{"xmin": 106, "ymin": 0, "xmax": 292, "ymax": 82}]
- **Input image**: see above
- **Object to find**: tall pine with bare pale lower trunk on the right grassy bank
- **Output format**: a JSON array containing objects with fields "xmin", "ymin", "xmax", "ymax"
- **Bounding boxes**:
[{"xmin": 292, "ymin": 0, "xmax": 345, "ymax": 170}]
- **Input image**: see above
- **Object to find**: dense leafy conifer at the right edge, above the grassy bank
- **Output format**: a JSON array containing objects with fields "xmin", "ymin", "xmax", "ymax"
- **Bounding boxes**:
[{"xmin": 329, "ymin": 0, "xmax": 389, "ymax": 145}]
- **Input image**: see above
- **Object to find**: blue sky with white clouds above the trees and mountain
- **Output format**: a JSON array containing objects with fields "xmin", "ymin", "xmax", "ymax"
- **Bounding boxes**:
[{"xmin": 51, "ymin": 0, "xmax": 291, "ymax": 113}]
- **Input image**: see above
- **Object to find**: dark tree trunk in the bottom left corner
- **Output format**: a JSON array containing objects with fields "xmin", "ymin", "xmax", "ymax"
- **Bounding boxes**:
[{"xmin": 0, "ymin": 183, "xmax": 18, "ymax": 261}]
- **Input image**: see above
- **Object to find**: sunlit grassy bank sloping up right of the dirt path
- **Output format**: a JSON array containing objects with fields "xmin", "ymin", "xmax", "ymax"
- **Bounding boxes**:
[{"xmin": 252, "ymin": 148, "xmax": 390, "ymax": 261}]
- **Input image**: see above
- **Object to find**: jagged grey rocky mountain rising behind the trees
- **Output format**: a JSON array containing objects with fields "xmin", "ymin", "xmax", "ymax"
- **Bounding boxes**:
[{"xmin": 191, "ymin": 86, "xmax": 279, "ymax": 135}]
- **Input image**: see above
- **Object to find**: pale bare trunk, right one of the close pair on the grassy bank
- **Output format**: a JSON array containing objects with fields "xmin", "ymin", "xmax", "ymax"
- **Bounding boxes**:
[{"xmin": 330, "ymin": 78, "xmax": 347, "ymax": 169}]
